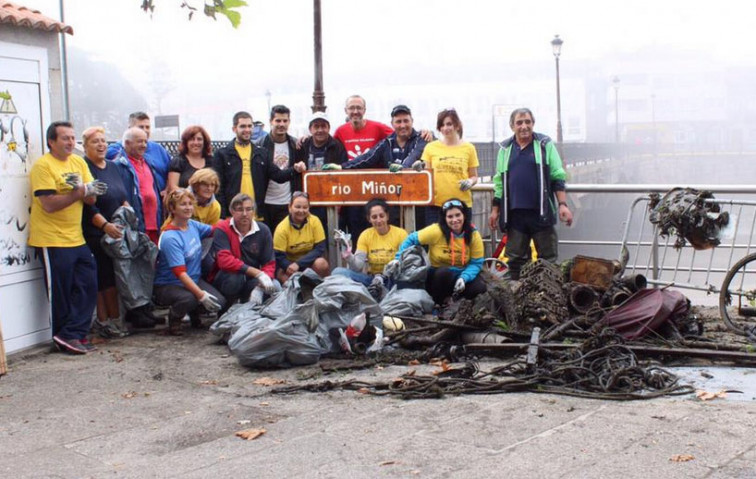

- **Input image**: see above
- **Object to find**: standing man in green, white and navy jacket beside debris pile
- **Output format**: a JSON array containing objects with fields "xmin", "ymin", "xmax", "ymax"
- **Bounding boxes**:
[{"xmin": 488, "ymin": 108, "xmax": 572, "ymax": 280}]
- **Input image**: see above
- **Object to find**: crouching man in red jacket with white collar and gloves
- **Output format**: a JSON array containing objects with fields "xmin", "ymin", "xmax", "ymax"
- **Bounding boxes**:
[{"xmin": 208, "ymin": 193, "xmax": 278, "ymax": 307}]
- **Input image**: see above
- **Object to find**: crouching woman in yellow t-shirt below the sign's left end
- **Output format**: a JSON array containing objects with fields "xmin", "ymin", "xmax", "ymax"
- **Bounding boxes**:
[{"xmin": 273, "ymin": 191, "xmax": 330, "ymax": 284}]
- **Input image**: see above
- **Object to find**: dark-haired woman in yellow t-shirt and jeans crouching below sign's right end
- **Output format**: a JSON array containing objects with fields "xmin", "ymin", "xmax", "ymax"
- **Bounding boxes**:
[{"xmin": 333, "ymin": 198, "xmax": 407, "ymax": 286}]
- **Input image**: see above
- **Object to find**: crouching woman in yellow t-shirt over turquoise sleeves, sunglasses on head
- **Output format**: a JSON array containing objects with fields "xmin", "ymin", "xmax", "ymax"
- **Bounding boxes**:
[{"xmin": 386, "ymin": 198, "xmax": 486, "ymax": 305}]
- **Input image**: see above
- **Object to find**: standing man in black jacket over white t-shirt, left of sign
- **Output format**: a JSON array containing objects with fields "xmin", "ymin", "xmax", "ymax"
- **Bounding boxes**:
[{"xmin": 258, "ymin": 105, "xmax": 305, "ymax": 231}]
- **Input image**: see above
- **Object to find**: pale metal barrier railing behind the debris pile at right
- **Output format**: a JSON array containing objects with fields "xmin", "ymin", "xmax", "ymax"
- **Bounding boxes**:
[{"xmin": 473, "ymin": 184, "xmax": 756, "ymax": 300}]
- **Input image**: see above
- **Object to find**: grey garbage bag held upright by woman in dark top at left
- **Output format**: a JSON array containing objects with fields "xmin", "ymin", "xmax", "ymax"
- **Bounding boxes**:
[{"xmin": 100, "ymin": 206, "xmax": 158, "ymax": 310}]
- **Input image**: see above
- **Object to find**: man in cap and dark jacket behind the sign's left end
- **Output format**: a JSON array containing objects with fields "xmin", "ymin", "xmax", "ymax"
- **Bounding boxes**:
[{"xmin": 302, "ymin": 111, "xmax": 347, "ymax": 234}]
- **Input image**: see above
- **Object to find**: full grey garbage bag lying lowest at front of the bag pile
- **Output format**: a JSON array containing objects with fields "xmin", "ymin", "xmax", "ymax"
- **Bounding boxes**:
[{"xmin": 228, "ymin": 316, "xmax": 321, "ymax": 368}]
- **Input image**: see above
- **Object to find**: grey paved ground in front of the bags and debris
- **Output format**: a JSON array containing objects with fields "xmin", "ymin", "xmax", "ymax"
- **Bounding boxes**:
[{"xmin": 0, "ymin": 332, "xmax": 756, "ymax": 478}]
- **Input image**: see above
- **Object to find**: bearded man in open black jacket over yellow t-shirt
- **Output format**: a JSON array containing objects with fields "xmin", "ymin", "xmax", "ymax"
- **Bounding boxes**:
[{"xmin": 213, "ymin": 111, "xmax": 306, "ymax": 219}]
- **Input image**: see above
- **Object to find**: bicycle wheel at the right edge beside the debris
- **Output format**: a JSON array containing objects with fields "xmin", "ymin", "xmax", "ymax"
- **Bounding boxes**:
[{"xmin": 719, "ymin": 253, "xmax": 756, "ymax": 339}]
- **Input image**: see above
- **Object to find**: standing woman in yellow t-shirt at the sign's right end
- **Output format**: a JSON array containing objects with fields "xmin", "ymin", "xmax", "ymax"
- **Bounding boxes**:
[{"xmin": 420, "ymin": 108, "xmax": 479, "ymax": 225}]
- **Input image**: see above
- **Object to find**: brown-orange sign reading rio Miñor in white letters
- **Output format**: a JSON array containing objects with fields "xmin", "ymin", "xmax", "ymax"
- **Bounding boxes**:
[{"xmin": 303, "ymin": 170, "xmax": 433, "ymax": 206}]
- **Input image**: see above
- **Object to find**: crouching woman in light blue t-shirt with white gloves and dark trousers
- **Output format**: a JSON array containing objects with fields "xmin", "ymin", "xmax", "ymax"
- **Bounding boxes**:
[{"xmin": 154, "ymin": 188, "xmax": 226, "ymax": 336}]
